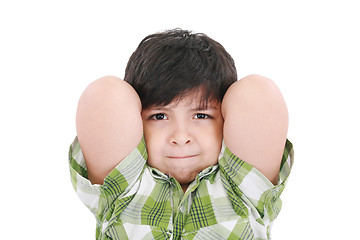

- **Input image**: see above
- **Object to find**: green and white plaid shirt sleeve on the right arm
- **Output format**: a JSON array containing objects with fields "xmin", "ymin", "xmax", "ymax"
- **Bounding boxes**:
[{"xmin": 219, "ymin": 140, "xmax": 294, "ymax": 223}]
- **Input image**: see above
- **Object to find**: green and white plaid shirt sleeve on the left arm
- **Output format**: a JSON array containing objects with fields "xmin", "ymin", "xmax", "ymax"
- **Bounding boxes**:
[{"xmin": 69, "ymin": 137, "xmax": 147, "ymax": 219}]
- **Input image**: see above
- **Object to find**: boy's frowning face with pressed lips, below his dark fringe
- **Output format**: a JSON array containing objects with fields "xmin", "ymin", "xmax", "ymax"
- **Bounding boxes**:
[{"xmin": 142, "ymin": 93, "xmax": 224, "ymax": 189}]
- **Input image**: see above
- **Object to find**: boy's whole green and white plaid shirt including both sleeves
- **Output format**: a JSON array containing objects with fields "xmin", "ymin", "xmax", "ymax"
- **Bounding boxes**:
[{"xmin": 69, "ymin": 139, "xmax": 293, "ymax": 240}]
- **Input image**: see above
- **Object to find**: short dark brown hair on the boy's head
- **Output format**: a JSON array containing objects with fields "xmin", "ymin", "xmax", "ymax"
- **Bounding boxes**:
[{"xmin": 124, "ymin": 29, "xmax": 237, "ymax": 109}]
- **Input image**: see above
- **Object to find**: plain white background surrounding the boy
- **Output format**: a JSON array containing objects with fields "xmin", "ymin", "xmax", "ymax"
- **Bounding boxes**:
[{"xmin": 0, "ymin": 0, "xmax": 360, "ymax": 240}]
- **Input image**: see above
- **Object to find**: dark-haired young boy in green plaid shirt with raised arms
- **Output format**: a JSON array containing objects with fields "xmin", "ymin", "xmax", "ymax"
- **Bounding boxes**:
[{"xmin": 69, "ymin": 29, "xmax": 293, "ymax": 239}]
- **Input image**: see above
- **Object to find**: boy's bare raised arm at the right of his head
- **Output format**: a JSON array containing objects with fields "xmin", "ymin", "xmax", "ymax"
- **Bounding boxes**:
[{"xmin": 222, "ymin": 75, "xmax": 288, "ymax": 184}]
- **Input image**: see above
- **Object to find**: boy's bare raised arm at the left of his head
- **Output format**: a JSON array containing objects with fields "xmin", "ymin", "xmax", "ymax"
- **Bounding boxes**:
[{"xmin": 76, "ymin": 76, "xmax": 143, "ymax": 184}]
